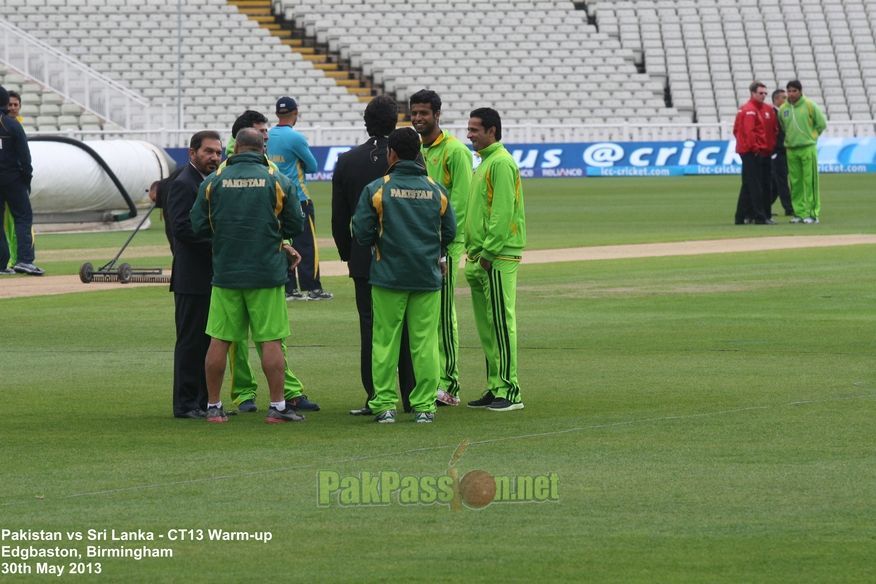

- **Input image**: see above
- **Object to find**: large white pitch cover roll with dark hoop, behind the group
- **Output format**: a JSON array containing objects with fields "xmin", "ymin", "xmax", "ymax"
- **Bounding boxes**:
[{"xmin": 29, "ymin": 140, "xmax": 173, "ymax": 213}]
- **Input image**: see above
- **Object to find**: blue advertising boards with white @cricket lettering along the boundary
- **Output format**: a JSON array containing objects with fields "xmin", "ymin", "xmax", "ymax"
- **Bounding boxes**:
[{"xmin": 167, "ymin": 138, "xmax": 876, "ymax": 181}]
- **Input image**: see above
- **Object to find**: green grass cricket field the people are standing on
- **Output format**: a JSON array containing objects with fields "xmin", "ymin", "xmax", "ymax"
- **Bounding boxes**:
[{"xmin": 0, "ymin": 176, "xmax": 876, "ymax": 583}]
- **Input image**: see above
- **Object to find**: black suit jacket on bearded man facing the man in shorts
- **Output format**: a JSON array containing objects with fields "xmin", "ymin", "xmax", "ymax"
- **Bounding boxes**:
[{"xmin": 164, "ymin": 163, "xmax": 213, "ymax": 295}]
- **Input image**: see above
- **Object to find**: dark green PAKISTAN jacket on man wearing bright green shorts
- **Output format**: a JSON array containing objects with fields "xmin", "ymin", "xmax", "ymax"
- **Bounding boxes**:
[{"xmin": 190, "ymin": 152, "xmax": 304, "ymax": 289}]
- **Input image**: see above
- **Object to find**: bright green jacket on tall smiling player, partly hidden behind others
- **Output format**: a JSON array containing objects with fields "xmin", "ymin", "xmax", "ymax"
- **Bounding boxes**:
[{"xmin": 422, "ymin": 130, "xmax": 472, "ymax": 249}]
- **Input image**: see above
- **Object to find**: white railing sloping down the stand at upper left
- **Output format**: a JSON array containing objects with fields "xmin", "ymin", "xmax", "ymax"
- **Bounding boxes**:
[{"xmin": 0, "ymin": 21, "xmax": 176, "ymax": 130}]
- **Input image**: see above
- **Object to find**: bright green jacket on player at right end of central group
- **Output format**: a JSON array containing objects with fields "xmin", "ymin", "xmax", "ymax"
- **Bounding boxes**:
[{"xmin": 465, "ymin": 142, "xmax": 526, "ymax": 262}]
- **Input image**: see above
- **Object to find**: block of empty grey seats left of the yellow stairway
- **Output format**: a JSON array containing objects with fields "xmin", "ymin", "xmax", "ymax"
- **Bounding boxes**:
[{"xmin": 0, "ymin": 0, "xmax": 362, "ymax": 140}]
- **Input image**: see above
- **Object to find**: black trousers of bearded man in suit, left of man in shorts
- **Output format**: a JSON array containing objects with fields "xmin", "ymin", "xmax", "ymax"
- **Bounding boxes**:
[{"xmin": 173, "ymin": 293, "xmax": 210, "ymax": 416}]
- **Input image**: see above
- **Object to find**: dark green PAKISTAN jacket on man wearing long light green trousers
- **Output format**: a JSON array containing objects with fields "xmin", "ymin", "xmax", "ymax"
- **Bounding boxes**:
[{"xmin": 353, "ymin": 160, "xmax": 456, "ymax": 291}]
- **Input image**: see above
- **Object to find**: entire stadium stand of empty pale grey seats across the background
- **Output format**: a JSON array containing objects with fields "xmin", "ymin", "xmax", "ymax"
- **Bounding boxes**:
[{"xmin": 0, "ymin": 0, "xmax": 876, "ymax": 144}]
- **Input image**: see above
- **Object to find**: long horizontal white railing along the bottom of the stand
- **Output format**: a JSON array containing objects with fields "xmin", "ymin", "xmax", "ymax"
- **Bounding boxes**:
[{"xmin": 30, "ymin": 120, "xmax": 876, "ymax": 148}]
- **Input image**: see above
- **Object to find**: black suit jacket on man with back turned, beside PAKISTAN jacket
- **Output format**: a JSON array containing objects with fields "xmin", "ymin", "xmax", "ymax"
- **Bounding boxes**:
[{"xmin": 332, "ymin": 137, "xmax": 389, "ymax": 278}]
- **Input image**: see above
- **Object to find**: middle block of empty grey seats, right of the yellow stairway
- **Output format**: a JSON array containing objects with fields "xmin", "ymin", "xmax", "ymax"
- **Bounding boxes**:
[{"xmin": 275, "ymin": 0, "xmax": 692, "ymax": 135}]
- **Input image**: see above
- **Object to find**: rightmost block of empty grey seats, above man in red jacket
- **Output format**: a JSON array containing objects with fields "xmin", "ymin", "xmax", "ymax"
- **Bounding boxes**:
[{"xmin": 586, "ymin": 0, "xmax": 876, "ymax": 137}]
